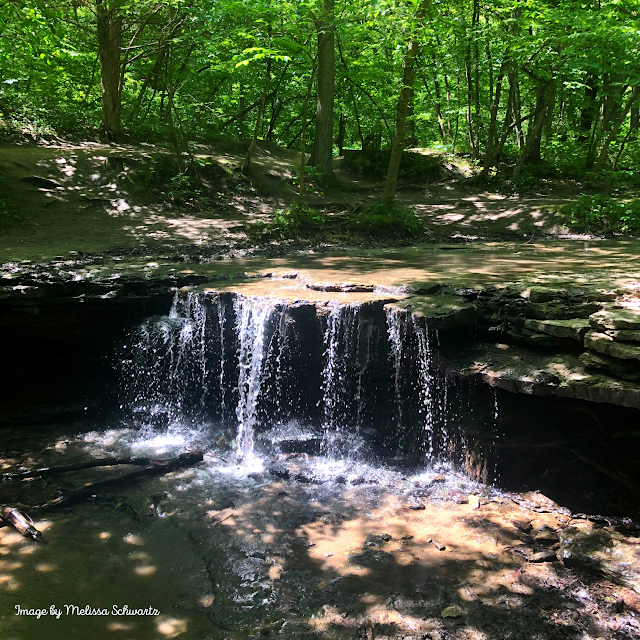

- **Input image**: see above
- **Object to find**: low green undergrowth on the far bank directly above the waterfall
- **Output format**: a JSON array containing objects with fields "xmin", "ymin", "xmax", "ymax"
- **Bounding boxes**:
[{"xmin": 248, "ymin": 202, "xmax": 424, "ymax": 240}]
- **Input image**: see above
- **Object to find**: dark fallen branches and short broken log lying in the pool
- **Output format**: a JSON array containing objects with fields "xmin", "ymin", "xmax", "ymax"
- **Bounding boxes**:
[{"xmin": 0, "ymin": 451, "xmax": 204, "ymax": 539}]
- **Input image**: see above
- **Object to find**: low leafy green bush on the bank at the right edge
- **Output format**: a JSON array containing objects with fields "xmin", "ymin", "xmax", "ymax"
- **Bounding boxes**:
[{"xmin": 560, "ymin": 195, "xmax": 640, "ymax": 235}]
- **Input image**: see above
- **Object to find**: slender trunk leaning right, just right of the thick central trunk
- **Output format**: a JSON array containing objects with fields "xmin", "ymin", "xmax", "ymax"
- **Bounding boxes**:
[{"xmin": 382, "ymin": 0, "xmax": 430, "ymax": 206}]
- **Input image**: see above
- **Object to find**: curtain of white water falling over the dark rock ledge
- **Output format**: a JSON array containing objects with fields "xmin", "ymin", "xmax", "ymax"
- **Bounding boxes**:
[{"xmin": 123, "ymin": 291, "xmax": 480, "ymax": 470}]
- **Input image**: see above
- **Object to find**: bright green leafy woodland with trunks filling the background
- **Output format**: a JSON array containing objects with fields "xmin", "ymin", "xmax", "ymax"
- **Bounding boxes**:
[{"xmin": 0, "ymin": 0, "xmax": 640, "ymax": 182}]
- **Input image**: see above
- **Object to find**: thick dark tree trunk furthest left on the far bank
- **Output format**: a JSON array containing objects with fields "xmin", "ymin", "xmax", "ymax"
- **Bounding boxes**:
[{"xmin": 96, "ymin": 0, "xmax": 122, "ymax": 140}]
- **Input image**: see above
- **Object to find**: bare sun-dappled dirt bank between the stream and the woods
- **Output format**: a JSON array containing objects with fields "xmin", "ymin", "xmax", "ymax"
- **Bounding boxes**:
[{"xmin": 0, "ymin": 142, "xmax": 577, "ymax": 263}]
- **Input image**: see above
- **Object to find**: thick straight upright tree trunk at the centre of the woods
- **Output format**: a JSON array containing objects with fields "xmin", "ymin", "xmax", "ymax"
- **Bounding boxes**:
[{"xmin": 309, "ymin": 0, "xmax": 335, "ymax": 184}]
